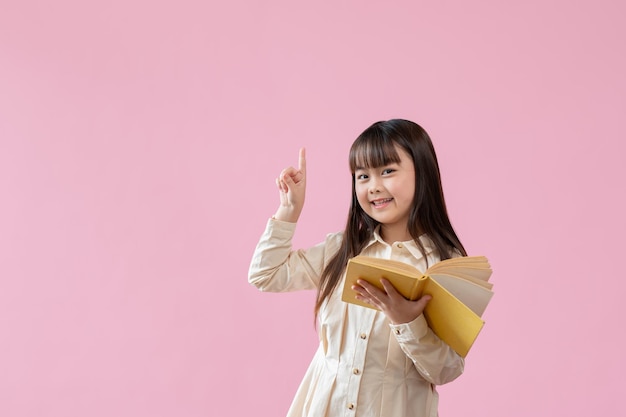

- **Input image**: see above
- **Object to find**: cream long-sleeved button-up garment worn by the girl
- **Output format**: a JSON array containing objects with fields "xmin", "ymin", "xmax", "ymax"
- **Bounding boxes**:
[{"xmin": 249, "ymin": 219, "xmax": 464, "ymax": 417}]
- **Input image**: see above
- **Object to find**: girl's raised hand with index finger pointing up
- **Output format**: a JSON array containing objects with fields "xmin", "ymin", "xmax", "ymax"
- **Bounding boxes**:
[{"xmin": 274, "ymin": 148, "xmax": 306, "ymax": 223}]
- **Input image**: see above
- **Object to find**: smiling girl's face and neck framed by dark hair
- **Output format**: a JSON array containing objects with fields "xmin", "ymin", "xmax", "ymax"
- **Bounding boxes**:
[{"xmin": 354, "ymin": 145, "xmax": 415, "ymax": 239}]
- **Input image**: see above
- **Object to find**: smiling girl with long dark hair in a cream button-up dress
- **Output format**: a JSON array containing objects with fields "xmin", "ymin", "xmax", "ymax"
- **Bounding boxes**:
[{"xmin": 249, "ymin": 119, "xmax": 467, "ymax": 417}]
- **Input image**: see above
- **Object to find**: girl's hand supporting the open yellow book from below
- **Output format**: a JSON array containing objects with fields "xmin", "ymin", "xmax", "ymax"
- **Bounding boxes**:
[{"xmin": 352, "ymin": 278, "xmax": 431, "ymax": 324}]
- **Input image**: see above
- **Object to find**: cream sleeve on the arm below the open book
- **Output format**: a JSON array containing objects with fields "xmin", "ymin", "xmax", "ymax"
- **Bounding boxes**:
[{"xmin": 390, "ymin": 315, "xmax": 465, "ymax": 385}]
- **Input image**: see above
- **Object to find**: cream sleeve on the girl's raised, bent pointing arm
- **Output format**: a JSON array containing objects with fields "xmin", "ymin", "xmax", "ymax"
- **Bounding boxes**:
[{"xmin": 248, "ymin": 219, "xmax": 341, "ymax": 292}]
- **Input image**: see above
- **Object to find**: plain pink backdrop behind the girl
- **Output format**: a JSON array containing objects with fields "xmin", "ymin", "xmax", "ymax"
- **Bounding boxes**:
[{"xmin": 0, "ymin": 0, "xmax": 626, "ymax": 417}]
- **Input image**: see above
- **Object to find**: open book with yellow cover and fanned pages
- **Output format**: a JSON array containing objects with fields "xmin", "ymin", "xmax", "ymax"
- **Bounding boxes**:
[{"xmin": 341, "ymin": 255, "xmax": 493, "ymax": 357}]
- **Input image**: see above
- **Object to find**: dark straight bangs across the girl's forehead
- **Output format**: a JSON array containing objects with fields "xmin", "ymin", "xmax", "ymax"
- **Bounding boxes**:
[{"xmin": 350, "ymin": 131, "xmax": 400, "ymax": 173}]
